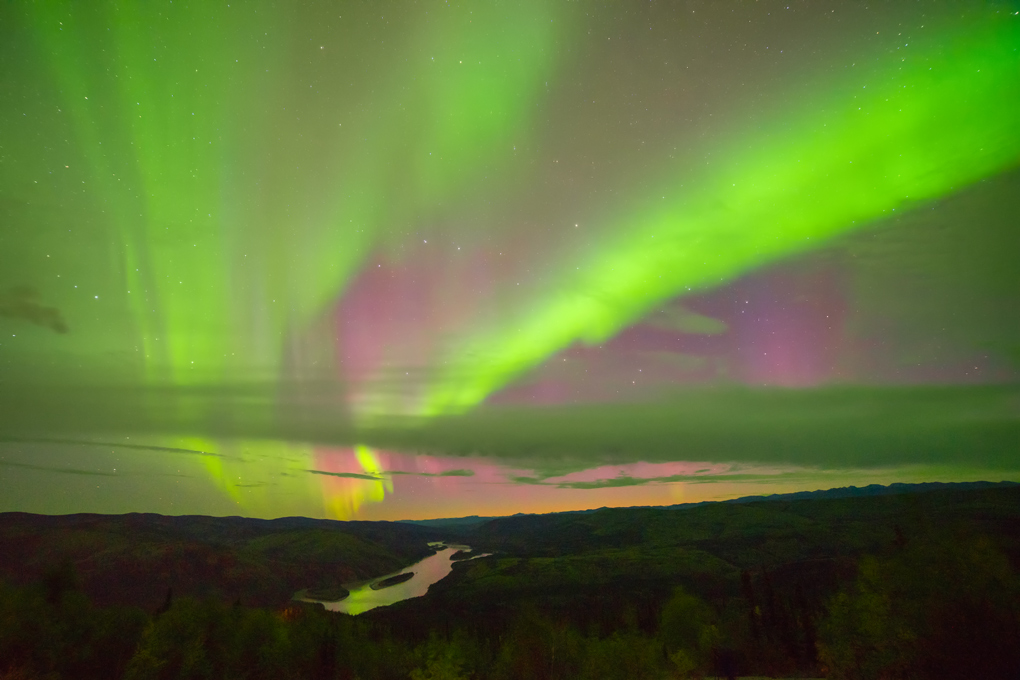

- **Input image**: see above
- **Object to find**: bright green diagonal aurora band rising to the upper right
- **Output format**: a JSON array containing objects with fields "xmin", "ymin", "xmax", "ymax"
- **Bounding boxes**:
[{"xmin": 412, "ymin": 15, "xmax": 1020, "ymax": 416}]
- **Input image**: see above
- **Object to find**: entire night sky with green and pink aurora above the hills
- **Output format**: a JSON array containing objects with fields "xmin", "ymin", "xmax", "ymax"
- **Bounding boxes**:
[{"xmin": 0, "ymin": 0, "xmax": 1020, "ymax": 519}]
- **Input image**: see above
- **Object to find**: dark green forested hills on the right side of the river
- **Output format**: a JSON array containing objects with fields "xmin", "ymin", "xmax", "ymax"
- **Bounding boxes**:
[{"xmin": 366, "ymin": 485, "xmax": 1020, "ymax": 639}]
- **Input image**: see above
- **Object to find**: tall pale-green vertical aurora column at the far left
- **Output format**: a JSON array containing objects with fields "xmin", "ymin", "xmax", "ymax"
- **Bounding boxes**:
[{"xmin": 29, "ymin": 2, "xmax": 271, "ymax": 384}]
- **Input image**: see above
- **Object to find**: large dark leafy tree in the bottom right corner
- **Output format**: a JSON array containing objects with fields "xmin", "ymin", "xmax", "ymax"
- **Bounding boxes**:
[{"xmin": 819, "ymin": 537, "xmax": 1020, "ymax": 680}]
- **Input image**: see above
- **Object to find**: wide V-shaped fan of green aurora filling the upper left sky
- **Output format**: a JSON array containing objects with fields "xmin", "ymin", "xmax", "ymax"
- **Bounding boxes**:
[{"xmin": 17, "ymin": 0, "xmax": 554, "ymax": 384}]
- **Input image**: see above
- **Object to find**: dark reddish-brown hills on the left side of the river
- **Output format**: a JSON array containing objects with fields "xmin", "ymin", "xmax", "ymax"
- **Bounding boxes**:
[{"xmin": 0, "ymin": 513, "xmax": 442, "ymax": 609}]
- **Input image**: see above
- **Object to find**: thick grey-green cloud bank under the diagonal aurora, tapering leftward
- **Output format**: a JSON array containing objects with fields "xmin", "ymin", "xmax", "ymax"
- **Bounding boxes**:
[{"xmin": 361, "ymin": 385, "xmax": 1020, "ymax": 483}]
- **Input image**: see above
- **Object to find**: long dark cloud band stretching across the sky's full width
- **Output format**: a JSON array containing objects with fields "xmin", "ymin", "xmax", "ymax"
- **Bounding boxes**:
[{"xmin": 0, "ymin": 383, "xmax": 1020, "ymax": 483}]
